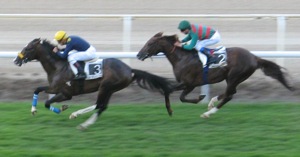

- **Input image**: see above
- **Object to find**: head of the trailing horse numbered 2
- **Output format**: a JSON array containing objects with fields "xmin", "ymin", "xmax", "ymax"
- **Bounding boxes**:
[{"xmin": 137, "ymin": 32, "xmax": 178, "ymax": 60}]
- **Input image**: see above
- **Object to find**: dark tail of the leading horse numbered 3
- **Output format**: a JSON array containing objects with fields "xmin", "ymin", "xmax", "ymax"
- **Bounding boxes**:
[{"xmin": 132, "ymin": 69, "xmax": 174, "ymax": 95}]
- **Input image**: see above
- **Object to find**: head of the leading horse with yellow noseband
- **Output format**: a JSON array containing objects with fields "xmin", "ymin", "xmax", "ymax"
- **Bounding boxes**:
[{"xmin": 14, "ymin": 38, "xmax": 41, "ymax": 66}]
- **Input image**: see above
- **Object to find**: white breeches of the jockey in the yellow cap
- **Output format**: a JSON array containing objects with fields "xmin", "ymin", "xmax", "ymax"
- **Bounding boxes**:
[{"xmin": 68, "ymin": 46, "xmax": 97, "ymax": 64}]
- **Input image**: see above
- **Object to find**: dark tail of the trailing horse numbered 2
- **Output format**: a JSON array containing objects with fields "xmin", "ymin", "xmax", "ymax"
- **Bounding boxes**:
[{"xmin": 257, "ymin": 57, "xmax": 295, "ymax": 91}]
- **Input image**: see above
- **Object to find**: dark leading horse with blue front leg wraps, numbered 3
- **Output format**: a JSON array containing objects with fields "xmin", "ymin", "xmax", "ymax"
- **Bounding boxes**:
[{"xmin": 14, "ymin": 39, "xmax": 173, "ymax": 128}]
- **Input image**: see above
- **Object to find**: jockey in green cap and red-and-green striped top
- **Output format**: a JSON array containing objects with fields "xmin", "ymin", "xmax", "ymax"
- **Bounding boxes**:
[{"xmin": 175, "ymin": 20, "xmax": 221, "ymax": 64}]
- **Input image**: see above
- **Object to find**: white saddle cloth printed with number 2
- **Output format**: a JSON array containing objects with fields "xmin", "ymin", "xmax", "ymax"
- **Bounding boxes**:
[{"xmin": 199, "ymin": 46, "xmax": 227, "ymax": 68}]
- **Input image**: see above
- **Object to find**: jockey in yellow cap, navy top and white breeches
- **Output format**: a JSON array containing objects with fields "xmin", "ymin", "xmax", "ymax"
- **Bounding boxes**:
[{"xmin": 53, "ymin": 31, "xmax": 97, "ymax": 80}]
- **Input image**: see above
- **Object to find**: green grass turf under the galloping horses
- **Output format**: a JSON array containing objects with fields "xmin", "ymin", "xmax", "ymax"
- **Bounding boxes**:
[{"xmin": 0, "ymin": 102, "xmax": 300, "ymax": 157}]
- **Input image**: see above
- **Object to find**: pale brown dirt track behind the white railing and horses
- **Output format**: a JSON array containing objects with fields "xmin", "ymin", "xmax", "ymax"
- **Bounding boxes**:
[{"xmin": 0, "ymin": 0, "xmax": 300, "ymax": 103}]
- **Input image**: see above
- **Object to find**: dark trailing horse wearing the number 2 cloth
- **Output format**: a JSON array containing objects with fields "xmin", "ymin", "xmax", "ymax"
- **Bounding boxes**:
[{"xmin": 137, "ymin": 33, "xmax": 294, "ymax": 118}]
